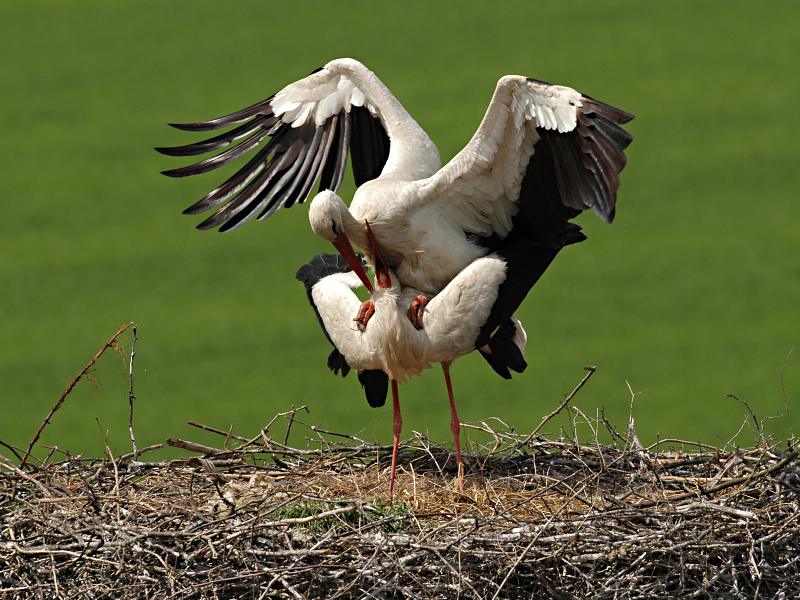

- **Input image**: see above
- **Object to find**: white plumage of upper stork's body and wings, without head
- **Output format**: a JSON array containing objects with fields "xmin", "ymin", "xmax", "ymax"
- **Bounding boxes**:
[{"xmin": 272, "ymin": 59, "xmax": 581, "ymax": 294}]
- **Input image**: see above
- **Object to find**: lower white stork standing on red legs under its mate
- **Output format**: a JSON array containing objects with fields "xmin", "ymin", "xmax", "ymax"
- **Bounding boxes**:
[{"xmin": 297, "ymin": 209, "xmax": 585, "ymax": 496}]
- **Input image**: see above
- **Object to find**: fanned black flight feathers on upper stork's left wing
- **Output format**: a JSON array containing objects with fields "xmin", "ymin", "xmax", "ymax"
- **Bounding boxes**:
[{"xmin": 156, "ymin": 69, "xmax": 389, "ymax": 231}]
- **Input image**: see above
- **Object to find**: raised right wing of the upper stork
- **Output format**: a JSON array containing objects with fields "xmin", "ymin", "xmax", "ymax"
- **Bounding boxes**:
[{"xmin": 418, "ymin": 76, "xmax": 633, "ymax": 238}]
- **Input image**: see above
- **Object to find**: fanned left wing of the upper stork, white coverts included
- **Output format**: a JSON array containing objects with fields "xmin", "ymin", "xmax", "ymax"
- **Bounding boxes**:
[{"xmin": 156, "ymin": 60, "xmax": 389, "ymax": 231}]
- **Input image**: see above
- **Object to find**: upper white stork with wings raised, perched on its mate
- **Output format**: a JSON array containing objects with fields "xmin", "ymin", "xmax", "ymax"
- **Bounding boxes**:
[{"xmin": 157, "ymin": 58, "xmax": 633, "ymax": 304}]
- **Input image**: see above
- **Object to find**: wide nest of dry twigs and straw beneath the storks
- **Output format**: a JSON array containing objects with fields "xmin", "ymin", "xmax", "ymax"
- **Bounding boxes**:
[{"xmin": 0, "ymin": 411, "xmax": 800, "ymax": 598}]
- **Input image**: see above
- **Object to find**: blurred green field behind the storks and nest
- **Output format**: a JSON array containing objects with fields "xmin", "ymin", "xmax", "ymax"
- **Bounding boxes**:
[{"xmin": 0, "ymin": 0, "xmax": 800, "ymax": 460}]
